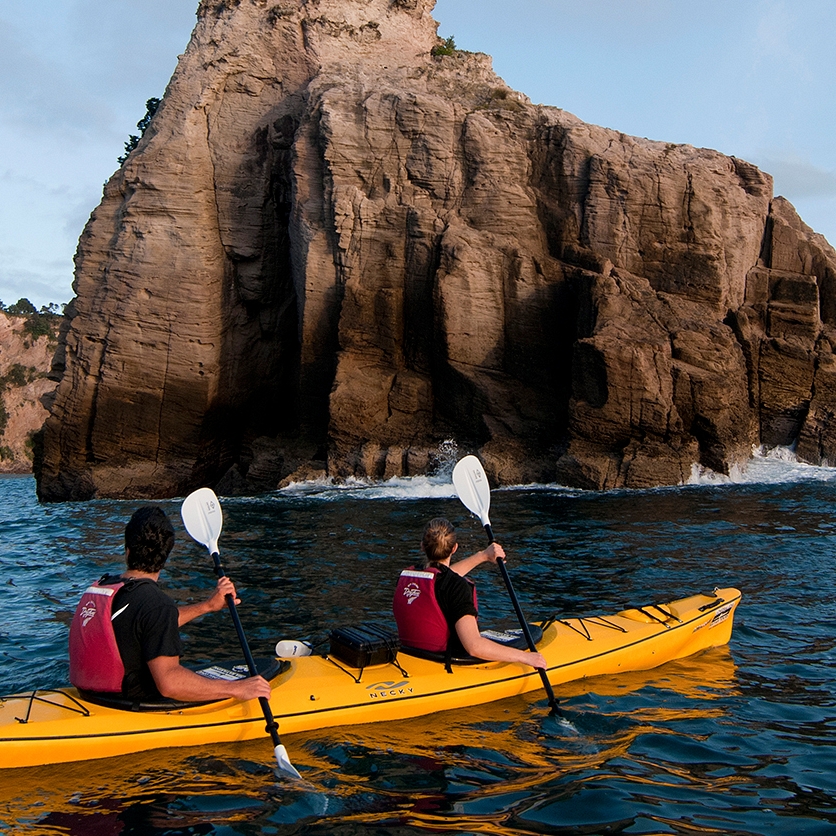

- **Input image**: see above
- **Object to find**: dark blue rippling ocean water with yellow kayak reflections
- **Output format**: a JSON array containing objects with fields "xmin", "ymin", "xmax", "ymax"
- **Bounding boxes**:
[{"xmin": 0, "ymin": 452, "xmax": 836, "ymax": 836}]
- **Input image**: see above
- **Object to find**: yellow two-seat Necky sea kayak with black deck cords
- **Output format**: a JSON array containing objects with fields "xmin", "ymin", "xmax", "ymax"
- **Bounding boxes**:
[{"xmin": 0, "ymin": 588, "xmax": 741, "ymax": 768}]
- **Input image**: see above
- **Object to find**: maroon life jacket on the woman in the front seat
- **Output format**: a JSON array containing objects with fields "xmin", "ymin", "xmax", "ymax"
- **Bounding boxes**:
[{"xmin": 392, "ymin": 566, "xmax": 479, "ymax": 653}]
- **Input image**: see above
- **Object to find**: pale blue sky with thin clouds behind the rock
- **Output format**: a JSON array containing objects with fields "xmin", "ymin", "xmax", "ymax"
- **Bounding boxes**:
[{"xmin": 0, "ymin": 0, "xmax": 836, "ymax": 307}]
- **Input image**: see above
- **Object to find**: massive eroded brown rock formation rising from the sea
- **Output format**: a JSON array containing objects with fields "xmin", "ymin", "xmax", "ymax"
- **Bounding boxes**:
[{"xmin": 38, "ymin": 0, "xmax": 836, "ymax": 500}]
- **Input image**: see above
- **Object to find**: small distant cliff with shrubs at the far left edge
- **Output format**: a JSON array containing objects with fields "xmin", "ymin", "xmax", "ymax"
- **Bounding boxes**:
[{"xmin": 0, "ymin": 311, "xmax": 59, "ymax": 473}]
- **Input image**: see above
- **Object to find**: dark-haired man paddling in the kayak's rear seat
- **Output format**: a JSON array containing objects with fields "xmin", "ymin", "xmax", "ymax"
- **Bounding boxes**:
[{"xmin": 70, "ymin": 506, "xmax": 270, "ymax": 702}]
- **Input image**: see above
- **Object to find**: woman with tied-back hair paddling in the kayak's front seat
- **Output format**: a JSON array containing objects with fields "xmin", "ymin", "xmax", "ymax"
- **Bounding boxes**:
[{"xmin": 393, "ymin": 517, "xmax": 546, "ymax": 669}]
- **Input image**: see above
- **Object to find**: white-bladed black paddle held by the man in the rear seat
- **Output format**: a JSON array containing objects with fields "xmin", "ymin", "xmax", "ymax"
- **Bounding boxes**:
[{"xmin": 180, "ymin": 488, "xmax": 302, "ymax": 778}]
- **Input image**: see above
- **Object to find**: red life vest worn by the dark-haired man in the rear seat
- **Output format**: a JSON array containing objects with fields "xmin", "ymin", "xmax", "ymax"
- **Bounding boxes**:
[{"xmin": 70, "ymin": 579, "xmax": 125, "ymax": 693}]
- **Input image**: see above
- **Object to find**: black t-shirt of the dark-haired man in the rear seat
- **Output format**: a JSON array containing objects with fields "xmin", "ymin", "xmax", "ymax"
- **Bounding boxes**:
[{"xmin": 106, "ymin": 578, "xmax": 183, "ymax": 700}]
